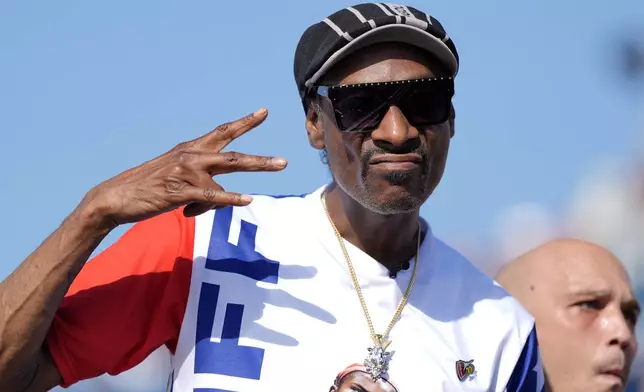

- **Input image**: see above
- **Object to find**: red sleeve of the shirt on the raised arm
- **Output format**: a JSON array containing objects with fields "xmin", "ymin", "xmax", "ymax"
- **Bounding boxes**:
[{"xmin": 47, "ymin": 210, "xmax": 195, "ymax": 387}]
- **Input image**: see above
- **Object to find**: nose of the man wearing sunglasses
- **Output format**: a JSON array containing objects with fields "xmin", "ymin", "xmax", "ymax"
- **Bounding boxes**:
[{"xmin": 371, "ymin": 105, "xmax": 420, "ymax": 150}]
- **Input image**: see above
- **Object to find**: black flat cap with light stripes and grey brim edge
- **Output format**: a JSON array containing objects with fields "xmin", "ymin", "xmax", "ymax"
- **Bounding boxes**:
[{"xmin": 293, "ymin": 3, "xmax": 458, "ymax": 111}]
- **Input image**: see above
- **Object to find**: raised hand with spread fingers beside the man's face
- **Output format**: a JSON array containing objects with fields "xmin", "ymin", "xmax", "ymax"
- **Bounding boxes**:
[{"xmin": 82, "ymin": 109, "xmax": 286, "ymax": 227}]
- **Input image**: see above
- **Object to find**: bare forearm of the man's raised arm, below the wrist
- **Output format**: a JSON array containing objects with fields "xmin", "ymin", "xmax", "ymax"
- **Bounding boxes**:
[{"xmin": 0, "ymin": 202, "xmax": 110, "ymax": 384}]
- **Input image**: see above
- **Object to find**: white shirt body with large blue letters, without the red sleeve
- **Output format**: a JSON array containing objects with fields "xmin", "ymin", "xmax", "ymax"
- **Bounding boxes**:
[{"xmin": 170, "ymin": 187, "xmax": 544, "ymax": 392}]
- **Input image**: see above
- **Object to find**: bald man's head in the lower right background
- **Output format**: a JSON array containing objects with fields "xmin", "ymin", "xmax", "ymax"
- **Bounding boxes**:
[{"xmin": 497, "ymin": 240, "xmax": 640, "ymax": 392}]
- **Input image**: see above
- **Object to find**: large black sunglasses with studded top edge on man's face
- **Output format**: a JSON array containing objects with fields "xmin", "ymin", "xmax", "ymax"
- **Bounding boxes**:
[{"xmin": 313, "ymin": 77, "xmax": 454, "ymax": 132}]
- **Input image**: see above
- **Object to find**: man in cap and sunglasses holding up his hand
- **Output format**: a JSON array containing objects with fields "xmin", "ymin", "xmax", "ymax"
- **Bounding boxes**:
[{"xmin": 0, "ymin": 3, "xmax": 543, "ymax": 392}]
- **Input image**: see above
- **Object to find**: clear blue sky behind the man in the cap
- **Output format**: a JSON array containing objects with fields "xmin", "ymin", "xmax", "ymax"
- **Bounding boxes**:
[{"xmin": 0, "ymin": 0, "xmax": 644, "ymax": 391}]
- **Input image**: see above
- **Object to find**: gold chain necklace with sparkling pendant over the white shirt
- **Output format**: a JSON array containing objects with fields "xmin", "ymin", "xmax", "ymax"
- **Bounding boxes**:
[{"xmin": 321, "ymin": 194, "xmax": 420, "ymax": 381}]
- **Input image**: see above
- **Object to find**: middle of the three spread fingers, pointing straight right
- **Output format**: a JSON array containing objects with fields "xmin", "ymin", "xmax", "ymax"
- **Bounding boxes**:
[{"xmin": 202, "ymin": 152, "xmax": 287, "ymax": 175}]
